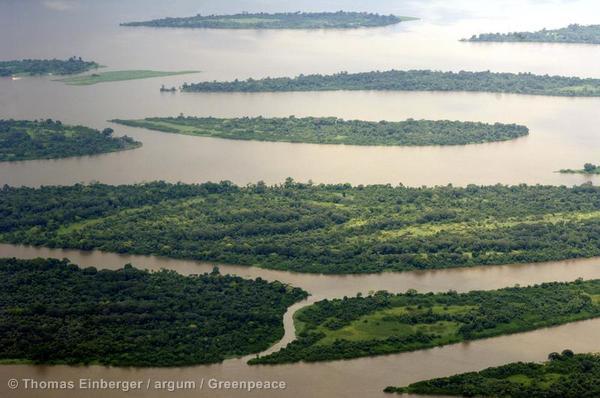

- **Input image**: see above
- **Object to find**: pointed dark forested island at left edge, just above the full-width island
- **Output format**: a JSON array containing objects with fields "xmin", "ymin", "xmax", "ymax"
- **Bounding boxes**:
[{"xmin": 0, "ymin": 119, "xmax": 142, "ymax": 162}]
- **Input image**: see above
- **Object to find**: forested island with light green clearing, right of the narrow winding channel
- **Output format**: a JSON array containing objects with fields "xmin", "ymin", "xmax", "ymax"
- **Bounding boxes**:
[{"xmin": 249, "ymin": 280, "xmax": 600, "ymax": 364}]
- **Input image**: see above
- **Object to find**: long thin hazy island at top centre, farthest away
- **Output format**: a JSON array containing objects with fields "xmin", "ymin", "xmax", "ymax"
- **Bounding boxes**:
[{"xmin": 121, "ymin": 11, "xmax": 416, "ymax": 29}]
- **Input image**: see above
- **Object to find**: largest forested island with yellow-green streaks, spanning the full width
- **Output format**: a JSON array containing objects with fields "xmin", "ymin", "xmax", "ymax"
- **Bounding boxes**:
[{"xmin": 5, "ymin": 179, "xmax": 600, "ymax": 273}]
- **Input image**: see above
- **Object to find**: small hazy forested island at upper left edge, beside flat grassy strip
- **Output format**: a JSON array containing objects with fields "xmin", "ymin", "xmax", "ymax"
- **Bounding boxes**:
[{"xmin": 0, "ymin": 57, "xmax": 100, "ymax": 77}]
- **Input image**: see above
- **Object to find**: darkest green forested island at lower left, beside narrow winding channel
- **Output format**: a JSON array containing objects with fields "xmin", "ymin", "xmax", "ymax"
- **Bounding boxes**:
[{"xmin": 0, "ymin": 259, "xmax": 307, "ymax": 367}]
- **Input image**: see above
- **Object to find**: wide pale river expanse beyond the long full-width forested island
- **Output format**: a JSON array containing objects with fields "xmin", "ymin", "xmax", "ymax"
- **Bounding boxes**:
[{"xmin": 0, "ymin": 0, "xmax": 600, "ymax": 186}]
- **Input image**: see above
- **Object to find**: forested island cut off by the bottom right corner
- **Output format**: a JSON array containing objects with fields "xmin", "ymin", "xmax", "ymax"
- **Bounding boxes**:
[{"xmin": 384, "ymin": 350, "xmax": 600, "ymax": 398}]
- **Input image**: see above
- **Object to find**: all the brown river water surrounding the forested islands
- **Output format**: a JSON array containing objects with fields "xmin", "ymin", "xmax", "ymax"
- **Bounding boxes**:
[{"xmin": 0, "ymin": 0, "xmax": 600, "ymax": 398}]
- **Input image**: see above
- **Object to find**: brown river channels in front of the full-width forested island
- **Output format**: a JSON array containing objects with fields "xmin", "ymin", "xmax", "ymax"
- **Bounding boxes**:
[{"xmin": 0, "ymin": 244, "xmax": 600, "ymax": 398}]
